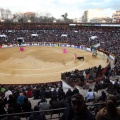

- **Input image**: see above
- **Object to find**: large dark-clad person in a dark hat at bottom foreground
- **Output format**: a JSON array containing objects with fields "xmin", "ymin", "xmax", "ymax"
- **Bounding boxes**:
[{"xmin": 60, "ymin": 94, "xmax": 95, "ymax": 120}]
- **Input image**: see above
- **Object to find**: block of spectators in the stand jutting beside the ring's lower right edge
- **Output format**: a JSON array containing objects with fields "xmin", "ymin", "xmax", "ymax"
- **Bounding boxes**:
[{"xmin": 61, "ymin": 65, "xmax": 111, "ymax": 86}]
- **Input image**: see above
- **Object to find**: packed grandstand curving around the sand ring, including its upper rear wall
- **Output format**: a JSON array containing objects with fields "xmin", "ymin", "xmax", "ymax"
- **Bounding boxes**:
[{"xmin": 0, "ymin": 23, "xmax": 120, "ymax": 119}]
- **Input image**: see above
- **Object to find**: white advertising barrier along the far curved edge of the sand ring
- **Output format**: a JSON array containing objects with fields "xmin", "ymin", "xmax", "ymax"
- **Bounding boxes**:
[{"xmin": 0, "ymin": 42, "xmax": 116, "ymax": 68}]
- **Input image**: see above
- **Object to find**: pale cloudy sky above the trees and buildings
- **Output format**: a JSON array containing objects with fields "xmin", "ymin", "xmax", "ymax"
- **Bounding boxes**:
[{"xmin": 0, "ymin": 0, "xmax": 120, "ymax": 19}]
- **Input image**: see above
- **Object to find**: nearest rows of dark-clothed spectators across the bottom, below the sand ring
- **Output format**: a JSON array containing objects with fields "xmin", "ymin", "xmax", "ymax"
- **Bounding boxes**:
[{"xmin": 0, "ymin": 78, "xmax": 120, "ymax": 120}]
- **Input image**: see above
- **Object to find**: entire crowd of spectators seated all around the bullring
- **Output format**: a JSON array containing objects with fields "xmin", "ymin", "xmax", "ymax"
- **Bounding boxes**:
[{"xmin": 0, "ymin": 24, "xmax": 120, "ymax": 120}]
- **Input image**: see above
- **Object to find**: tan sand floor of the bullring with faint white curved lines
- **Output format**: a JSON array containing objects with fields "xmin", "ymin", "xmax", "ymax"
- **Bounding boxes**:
[{"xmin": 0, "ymin": 46, "xmax": 107, "ymax": 84}]
